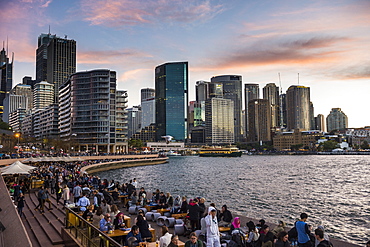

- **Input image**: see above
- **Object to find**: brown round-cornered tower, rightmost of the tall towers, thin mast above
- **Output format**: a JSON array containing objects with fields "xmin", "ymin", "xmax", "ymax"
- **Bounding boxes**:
[{"xmin": 286, "ymin": 85, "xmax": 311, "ymax": 131}]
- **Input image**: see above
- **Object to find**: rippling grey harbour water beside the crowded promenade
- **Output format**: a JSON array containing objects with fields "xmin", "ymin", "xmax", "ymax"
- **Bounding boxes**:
[{"xmin": 97, "ymin": 155, "xmax": 370, "ymax": 245}]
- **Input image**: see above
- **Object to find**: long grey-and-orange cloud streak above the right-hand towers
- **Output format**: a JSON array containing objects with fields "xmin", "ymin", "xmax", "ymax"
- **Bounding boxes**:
[{"xmin": 208, "ymin": 37, "xmax": 349, "ymax": 68}]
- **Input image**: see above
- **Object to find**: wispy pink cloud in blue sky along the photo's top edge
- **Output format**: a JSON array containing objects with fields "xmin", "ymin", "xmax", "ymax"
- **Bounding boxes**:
[{"xmin": 81, "ymin": 0, "xmax": 223, "ymax": 27}]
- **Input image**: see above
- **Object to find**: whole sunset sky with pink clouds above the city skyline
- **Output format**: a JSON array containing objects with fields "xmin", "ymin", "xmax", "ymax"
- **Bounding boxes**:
[{"xmin": 0, "ymin": 0, "xmax": 370, "ymax": 128}]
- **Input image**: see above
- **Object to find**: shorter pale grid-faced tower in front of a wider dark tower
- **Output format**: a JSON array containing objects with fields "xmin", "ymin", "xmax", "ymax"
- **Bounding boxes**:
[{"xmin": 205, "ymin": 98, "xmax": 235, "ymax": 144}]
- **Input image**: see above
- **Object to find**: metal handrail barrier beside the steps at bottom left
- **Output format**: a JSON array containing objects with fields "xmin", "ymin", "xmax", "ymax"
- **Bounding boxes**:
[{"xmin": 65, "ymin": 207, "xmax": 123, "ymax": 247}]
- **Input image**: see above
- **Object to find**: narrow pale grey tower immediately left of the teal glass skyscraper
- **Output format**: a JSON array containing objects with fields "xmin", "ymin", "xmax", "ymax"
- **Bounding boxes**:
[{"xmin": 141, "ymin": 88, "xmax": 155, "ymax": 128}]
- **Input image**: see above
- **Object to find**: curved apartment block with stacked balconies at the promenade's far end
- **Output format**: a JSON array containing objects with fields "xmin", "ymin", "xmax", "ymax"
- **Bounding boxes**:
[{"xmin": 59, "ymin": 69, "xmax": 127, "ymax": 153}]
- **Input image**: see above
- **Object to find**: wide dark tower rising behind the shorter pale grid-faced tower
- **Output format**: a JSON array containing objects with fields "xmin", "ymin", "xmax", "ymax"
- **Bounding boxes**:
[{"xmin": 211, "ymin": 75, "xmax": 244, "ymax": 142}]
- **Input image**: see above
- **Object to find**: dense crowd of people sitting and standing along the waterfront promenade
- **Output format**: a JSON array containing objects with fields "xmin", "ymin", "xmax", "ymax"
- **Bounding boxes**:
[{"xmin": 6, "ymin": 158, "xmax": 370, "ymax": 247}]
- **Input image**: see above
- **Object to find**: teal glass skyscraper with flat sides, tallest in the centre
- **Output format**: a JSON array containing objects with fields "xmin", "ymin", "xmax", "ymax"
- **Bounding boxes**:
[{"xmin": 155, "ymin": 62, "xmax": 188, "ymax": 141}]
